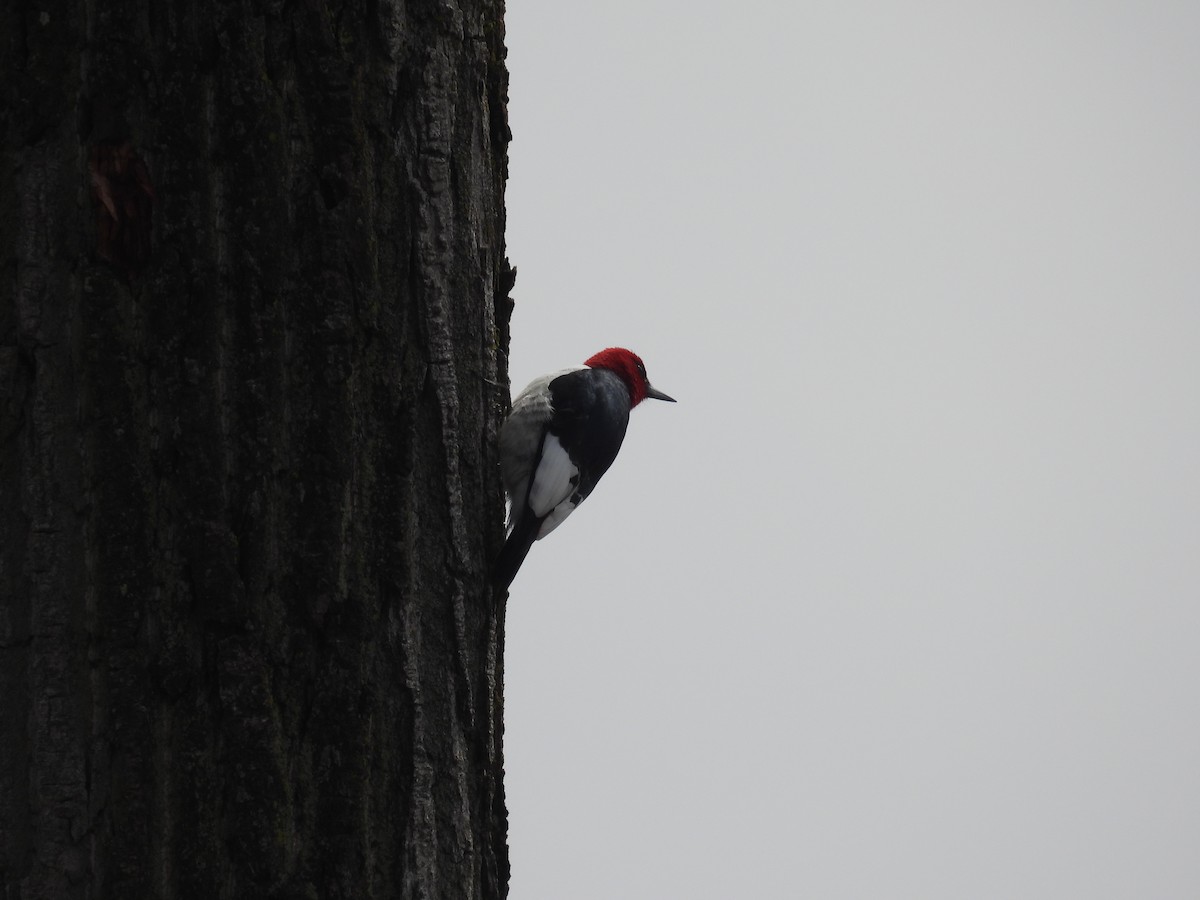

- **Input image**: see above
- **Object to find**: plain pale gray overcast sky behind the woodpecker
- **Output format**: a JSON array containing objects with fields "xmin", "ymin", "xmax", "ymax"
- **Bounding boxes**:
[{"xmin": 505, "ymin": 0, "xmax": 1200, "ymax": 900}]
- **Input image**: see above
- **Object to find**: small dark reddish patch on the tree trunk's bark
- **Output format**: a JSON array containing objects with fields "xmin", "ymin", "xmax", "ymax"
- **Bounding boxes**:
[{"xmin": 88, "ymin": 140, "xmax": 154, "ymax": 274}]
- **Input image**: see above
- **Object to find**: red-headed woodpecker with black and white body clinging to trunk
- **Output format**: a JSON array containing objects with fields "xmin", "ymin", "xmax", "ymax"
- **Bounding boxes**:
[{"xmin": 492, "ymin": 347, "xmax": 676, "ymax": 588}]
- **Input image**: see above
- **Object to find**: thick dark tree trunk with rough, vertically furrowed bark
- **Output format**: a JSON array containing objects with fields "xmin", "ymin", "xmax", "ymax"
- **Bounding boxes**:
[{"xmin": 0, "ymin": 0, "xmax": 511, "ymax": 900}]
